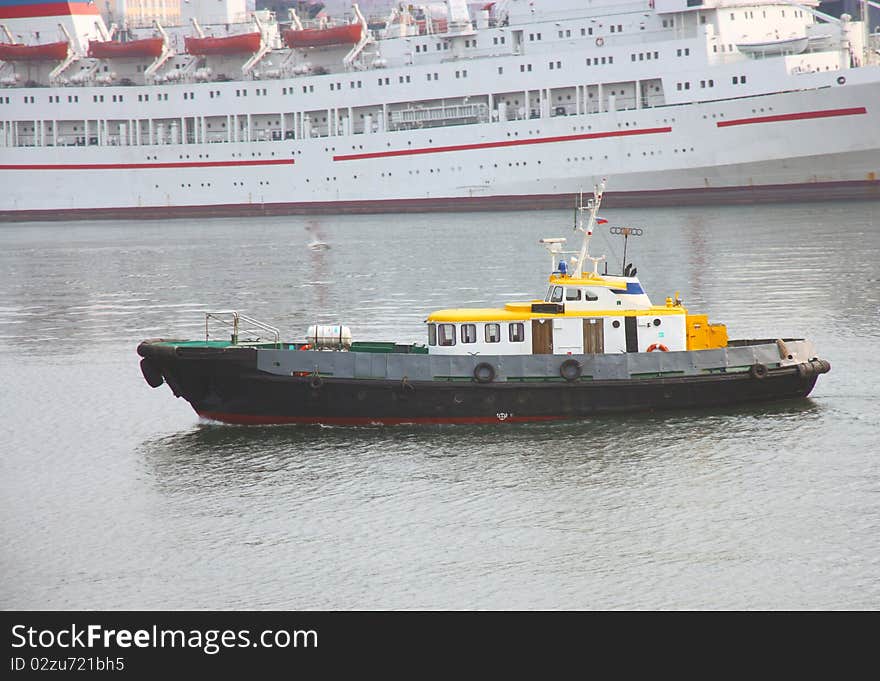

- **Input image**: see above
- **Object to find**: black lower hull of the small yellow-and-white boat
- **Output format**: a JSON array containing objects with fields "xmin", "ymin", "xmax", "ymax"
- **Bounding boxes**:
[{"xmin": 139, "ymin": 344, "xmax": 830, "ymax": 425}]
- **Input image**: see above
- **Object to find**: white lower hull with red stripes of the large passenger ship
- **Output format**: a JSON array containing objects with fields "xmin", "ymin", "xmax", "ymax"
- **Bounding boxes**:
[{"xmin": 0, "ymin": 71, "xmax": 880, "ymax": 221}]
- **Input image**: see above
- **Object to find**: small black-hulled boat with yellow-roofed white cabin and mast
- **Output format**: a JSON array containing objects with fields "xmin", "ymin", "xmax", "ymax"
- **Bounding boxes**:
[{"xmin": 138, "ymin": 182, "xmax": 831, "ymax": 425}]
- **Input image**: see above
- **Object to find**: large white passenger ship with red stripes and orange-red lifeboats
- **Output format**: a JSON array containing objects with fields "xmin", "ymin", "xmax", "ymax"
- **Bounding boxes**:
[{"xmin": 0, "ymin": 0, "xmax": 880, "ymax": 221}]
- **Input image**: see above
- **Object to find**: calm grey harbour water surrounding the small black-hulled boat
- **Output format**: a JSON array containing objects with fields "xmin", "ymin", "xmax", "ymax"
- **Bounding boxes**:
[{"xmin": 0, "ymin": 203, "xmax": 880, "ymax": 609}]
